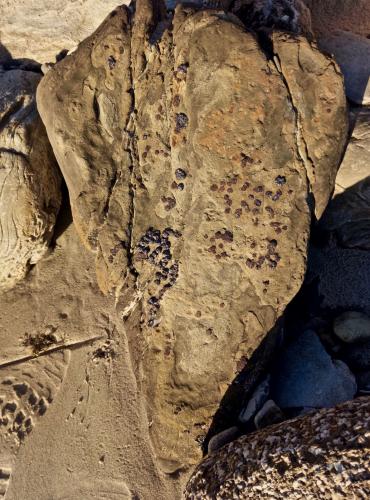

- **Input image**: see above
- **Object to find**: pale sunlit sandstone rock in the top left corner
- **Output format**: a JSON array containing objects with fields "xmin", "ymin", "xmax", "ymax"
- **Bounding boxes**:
[{"xmin": 0, "ymin": 0, "xmax": 130, "ymax": 62}]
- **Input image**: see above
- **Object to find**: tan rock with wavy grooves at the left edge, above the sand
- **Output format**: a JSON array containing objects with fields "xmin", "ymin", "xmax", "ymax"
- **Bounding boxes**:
[{"xmin": 0, "ymin": 70, "xmax": 61, "ymax": 290}]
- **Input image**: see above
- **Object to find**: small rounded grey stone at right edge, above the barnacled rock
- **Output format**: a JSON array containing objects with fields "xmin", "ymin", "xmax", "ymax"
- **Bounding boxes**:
[{"xmin": 333, "ymin": 311, "xmax": 370, "ymax": 344}]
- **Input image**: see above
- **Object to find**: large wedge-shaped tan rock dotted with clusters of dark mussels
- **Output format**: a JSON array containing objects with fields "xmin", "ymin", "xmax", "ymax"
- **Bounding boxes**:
[{"xmin": 38, "ymin": 1, "xmax": 347, "ymax": 472}]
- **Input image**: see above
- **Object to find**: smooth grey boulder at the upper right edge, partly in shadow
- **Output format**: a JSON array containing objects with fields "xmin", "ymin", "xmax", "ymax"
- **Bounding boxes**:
[{"xmin": 320, "ymin": 31, "xmax": 370, "ymax": 105}]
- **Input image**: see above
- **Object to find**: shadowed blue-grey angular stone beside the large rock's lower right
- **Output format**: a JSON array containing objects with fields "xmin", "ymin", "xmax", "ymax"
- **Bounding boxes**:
[{"xmin": 271, "ymin": 330, "xmax": 357, "ymax": 409}]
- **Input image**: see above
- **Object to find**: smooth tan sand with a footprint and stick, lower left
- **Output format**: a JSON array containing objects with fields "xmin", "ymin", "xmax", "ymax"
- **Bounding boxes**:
[{"xmin": 0, "ymin": 202, "xmax": 181, "ymax": 500}]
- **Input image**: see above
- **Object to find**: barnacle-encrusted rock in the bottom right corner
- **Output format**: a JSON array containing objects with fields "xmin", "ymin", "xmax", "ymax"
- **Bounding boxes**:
[{"xmin": 185, "ymin": 397, "xmax": 370, "ymax": 500}]
